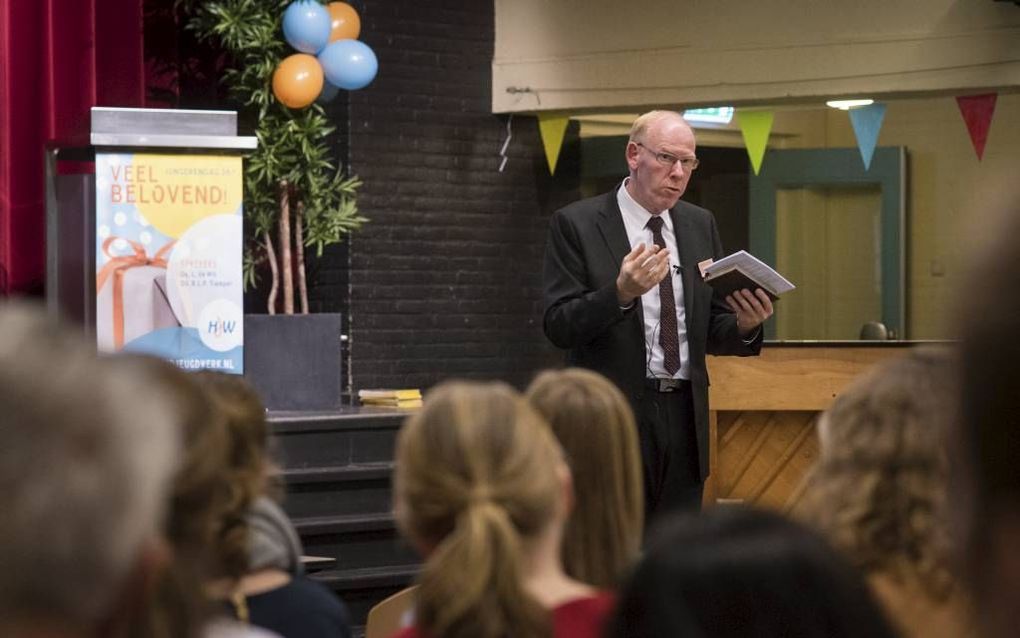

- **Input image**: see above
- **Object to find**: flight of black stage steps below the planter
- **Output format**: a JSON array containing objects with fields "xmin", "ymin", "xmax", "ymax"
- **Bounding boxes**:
[{"xmin": 268, "ymin": 407, "xmax": 419, "ymax": 626}]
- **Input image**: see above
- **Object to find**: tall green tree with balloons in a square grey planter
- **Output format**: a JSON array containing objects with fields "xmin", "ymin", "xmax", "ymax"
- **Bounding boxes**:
[{"xmin": 176, "ymin": 0, "xmax": 377, "ymax": 409}]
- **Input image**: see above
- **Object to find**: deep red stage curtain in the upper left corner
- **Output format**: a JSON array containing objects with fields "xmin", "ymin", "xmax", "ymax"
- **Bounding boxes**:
[{"xmin": 0, "ymin": 0, "xmax": 145, "ymax": 292}]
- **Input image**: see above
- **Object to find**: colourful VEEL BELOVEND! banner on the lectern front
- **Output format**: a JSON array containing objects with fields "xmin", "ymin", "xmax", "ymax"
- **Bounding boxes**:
[{"xmin": 96, "ymin": 152, "xmax": 244, "ymax": 375}]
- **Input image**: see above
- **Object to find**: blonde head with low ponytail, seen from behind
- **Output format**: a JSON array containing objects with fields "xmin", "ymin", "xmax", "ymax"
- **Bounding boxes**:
[{"xmin": 396, "ymin": 382, "xmax": 570, "ymax": 638}]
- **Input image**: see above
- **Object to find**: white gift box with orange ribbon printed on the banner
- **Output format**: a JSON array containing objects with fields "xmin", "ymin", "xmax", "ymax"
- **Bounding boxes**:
[{"xmin": 96, "ymin": 237, "xmax": 181, "ymax": 350}]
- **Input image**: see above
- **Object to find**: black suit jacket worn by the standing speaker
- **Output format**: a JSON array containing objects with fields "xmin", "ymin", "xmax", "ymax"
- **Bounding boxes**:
[{"xmin": 543, "ymin": 189, "xmax": 762, "ymax": 479}]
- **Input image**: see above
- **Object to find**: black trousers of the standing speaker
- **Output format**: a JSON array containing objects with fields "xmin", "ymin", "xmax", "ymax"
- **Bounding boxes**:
[{"xmin": 634, "ymin": 384, "xmax": 704, "ymax": 529}]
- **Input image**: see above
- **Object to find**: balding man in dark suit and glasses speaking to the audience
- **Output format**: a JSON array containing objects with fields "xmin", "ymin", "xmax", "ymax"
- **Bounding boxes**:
[{"xmin": 544, "ymin": 111, "xmax": 772, "ymax": 519}]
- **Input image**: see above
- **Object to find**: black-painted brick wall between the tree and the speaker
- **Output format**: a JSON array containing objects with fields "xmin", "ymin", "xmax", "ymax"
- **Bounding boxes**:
[{"xmin": 326, "ymin": 0, "xmax": 579, "ymax": 390}]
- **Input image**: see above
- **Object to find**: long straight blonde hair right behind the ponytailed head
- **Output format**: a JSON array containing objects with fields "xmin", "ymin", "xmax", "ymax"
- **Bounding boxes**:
[{"xmin": 525, "ymin": 369, "xmax": 645, "ymax": 588}]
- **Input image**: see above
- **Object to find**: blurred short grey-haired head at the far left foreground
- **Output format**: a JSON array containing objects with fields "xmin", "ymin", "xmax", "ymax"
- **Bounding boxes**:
[{"xmin": 0, "ymin": 302, "xmax": 177, "ymax": 635}]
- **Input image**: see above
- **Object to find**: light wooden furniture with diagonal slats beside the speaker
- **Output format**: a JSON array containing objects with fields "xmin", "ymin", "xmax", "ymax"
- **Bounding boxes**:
[{"xmin": 705, "ymin": 342, "xmax": 912, "ymax": 511}]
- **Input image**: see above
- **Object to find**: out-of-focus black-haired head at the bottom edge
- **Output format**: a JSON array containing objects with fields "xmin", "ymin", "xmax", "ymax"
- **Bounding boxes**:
[{"xmin": 609, "ymin": 506, "xmax": 895, "ymax": 638}]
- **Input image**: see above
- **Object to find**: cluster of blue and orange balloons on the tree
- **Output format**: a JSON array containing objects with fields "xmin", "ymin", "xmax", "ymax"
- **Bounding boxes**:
[{"xmin": 272, "ymin": 0, "xmax": 378, "ymax": 108}]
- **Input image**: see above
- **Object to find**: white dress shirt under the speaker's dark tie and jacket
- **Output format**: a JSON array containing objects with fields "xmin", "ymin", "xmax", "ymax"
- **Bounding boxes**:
[{"xmin": 616, "ymin": 178, "xmax": 691, "ymax": 379}]
